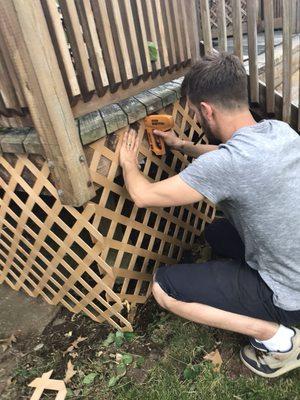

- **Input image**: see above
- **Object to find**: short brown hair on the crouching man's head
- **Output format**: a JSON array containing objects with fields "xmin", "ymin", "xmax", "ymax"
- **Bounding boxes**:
[{"xmin": 181, "ymin": 53, "xmax": 248, "ymax": 109}]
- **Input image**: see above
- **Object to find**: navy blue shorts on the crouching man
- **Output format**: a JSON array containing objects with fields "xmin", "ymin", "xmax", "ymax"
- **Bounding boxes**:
[{"xmin": 155, "ymin": 219, "xmax": 300, "ymax": 326}]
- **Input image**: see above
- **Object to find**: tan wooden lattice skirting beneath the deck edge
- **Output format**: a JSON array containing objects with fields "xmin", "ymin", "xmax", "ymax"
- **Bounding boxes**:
[{"xmin": 0, "ymin": 100, "xmax": 214, "ymax": 330}]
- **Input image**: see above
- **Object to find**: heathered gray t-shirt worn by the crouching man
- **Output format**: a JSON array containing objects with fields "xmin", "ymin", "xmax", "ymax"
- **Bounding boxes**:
[{"xmin": 179, "ymin": 120, "xmax": 300, "ymax": 310}]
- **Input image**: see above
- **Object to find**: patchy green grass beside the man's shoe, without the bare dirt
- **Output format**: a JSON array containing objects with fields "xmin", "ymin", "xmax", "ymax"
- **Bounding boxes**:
[{"xmin": 1, "ymin": 310, "xmax": 300, "ymax": 400}]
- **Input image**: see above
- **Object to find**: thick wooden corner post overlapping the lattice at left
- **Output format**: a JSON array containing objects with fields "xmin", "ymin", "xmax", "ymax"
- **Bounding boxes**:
[{"xmin": 0, "ymin": 0, "xmax": 95, "ymax": 206}]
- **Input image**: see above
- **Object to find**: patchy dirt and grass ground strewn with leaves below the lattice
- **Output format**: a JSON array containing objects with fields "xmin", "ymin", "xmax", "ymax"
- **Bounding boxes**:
[{"xmin": 0, "ymin": 239, "xmax": 300, "ymax": 400}]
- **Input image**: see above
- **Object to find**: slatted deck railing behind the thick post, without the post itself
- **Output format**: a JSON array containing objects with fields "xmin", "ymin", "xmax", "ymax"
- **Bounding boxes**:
[{"xmin": 0, "ymin": 0, "xmax": 199, "ymax": 126}]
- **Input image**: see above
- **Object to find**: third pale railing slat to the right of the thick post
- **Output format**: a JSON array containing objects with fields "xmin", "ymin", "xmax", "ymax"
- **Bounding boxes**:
[{"xmin": 75, "ymin": 0, "xmax": 108, "ymax": 95}]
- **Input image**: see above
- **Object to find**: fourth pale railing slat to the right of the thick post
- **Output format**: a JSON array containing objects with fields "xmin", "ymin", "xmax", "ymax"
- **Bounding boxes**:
[{"xmin": 91, "ymin": 0, "xmax": 121, "ymax": 88}]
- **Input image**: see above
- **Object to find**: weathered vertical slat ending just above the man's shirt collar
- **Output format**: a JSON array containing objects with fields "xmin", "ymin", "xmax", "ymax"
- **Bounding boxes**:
[{"xmin": 264, "ymin": 0, "xmax": 275, "ymax": 114}]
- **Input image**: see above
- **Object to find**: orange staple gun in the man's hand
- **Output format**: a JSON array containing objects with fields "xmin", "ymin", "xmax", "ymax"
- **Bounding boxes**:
[{"xmin": 145, "ymin": 114, "xmax": 174, "ymax": 156}]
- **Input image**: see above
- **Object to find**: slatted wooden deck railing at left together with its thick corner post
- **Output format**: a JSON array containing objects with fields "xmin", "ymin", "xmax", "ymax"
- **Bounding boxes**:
[{"xmin": 0, "ymin": 0, "xmax": 199, "ymax": 206}]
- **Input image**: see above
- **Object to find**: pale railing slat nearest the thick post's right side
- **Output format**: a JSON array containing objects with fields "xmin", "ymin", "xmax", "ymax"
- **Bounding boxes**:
[{"xmin": 42, "ymin": 0, "xmax": 80, "ymax": 99}]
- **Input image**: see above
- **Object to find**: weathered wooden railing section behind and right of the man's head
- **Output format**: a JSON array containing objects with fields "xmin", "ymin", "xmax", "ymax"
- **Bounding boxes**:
[{"xmin": 200, "ymin": 0, "xmax": 300, "ymax": 131}]
